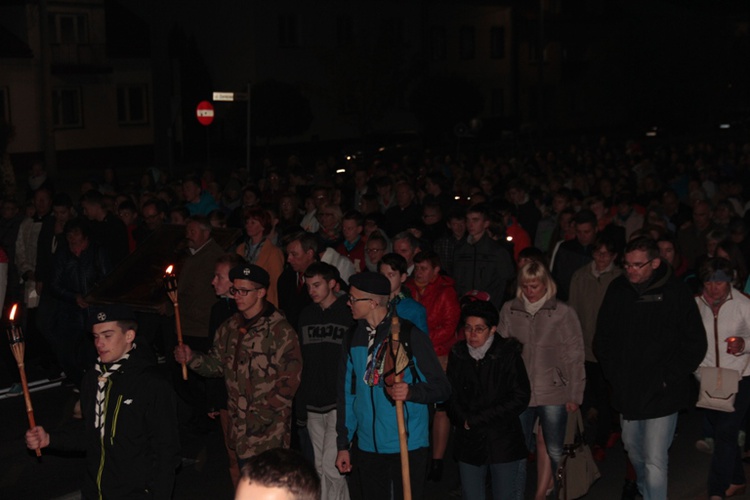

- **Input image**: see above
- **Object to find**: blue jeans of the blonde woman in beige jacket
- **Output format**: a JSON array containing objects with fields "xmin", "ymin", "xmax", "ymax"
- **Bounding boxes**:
[{"xmin": 519, "ymin": 405, "xmax": 568, "ymax": 496}]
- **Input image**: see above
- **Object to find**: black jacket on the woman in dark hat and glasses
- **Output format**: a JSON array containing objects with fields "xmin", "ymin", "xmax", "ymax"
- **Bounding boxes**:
[{"xmin": 448, "ymin": 334, "xmax": 531, "ymax": 465}]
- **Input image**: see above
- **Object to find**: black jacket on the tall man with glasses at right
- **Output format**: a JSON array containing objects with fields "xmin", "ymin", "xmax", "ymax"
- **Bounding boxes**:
[{"xmin": 594, "ymin": 263, "xmax": 707, "ymax": 420}]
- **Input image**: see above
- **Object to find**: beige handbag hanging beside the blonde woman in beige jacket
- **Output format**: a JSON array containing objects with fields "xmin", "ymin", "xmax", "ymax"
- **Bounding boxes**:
[{"xmin": 557, "ymin": 410, "xmax": 601, "ymax": 500}]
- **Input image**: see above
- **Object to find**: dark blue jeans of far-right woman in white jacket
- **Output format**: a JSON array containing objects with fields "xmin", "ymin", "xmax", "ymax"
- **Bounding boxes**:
[{"xmin": 706, "ymin": 377, "xmax": 750, "ymax": 496}]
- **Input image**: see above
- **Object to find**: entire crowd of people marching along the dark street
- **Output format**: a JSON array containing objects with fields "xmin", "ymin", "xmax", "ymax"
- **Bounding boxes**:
[{"xmin": 0, "ymin": 138, "xmax": 750, "ymax": 500}]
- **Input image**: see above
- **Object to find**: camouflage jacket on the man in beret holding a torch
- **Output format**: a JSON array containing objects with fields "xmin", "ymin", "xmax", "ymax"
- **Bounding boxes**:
[{"xmin": 189, "ymin": 304, "xmax": 302, "ymax": 458}]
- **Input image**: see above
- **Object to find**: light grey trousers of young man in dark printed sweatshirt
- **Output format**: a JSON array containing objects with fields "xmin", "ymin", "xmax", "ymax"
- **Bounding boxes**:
[{"xmin": 307, "ymin": 410, "xmax": 349, "ymax": 500}]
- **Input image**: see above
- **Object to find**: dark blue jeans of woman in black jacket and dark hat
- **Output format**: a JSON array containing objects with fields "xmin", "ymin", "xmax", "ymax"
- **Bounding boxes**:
[{"xmin": 458, "ymin": 459, "xmax": 526, "ymax": 500}]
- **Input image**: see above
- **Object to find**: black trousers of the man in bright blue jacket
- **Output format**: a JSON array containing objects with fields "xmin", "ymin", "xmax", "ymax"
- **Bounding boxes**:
[{"xmin": 352, "ymin": 448, "xmax": 429, "ymax": 500}]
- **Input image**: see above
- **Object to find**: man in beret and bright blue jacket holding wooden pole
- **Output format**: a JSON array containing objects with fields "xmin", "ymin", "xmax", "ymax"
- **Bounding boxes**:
[{"xmin": 336, "ymin": 272, "xmax": 450, "ymax": 500}]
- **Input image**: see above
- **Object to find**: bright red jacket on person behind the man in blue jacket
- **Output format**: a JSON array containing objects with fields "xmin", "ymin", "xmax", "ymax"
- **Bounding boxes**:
[{"xmin": 406, "ymin": 274, "xmax": 461, "ymax": 356}]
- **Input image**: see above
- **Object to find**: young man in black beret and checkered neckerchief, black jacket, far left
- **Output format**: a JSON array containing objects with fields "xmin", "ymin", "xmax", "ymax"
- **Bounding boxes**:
[{"xmin": 26, "ymin": 305, "xmax": 180, "ymax": 500}]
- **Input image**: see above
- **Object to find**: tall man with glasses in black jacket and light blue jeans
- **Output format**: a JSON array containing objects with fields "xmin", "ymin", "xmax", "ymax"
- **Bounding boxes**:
[{"xmin": 594, "ymin": 236, "xmax": 706, "ymax": 500}]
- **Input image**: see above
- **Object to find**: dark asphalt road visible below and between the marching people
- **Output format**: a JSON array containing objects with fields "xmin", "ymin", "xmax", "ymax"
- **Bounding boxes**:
[{"xmin": 0, "ymin": 360, "xmax": 750, "ymax": 500}]
